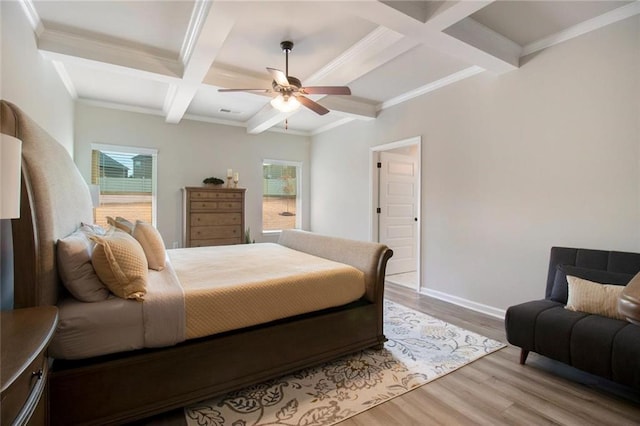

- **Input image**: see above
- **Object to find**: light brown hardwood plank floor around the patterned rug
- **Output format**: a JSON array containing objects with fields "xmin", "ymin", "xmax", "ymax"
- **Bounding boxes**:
[{"xmin": 139, "ymin": 284, "xmax": 640, "ymax": 426}]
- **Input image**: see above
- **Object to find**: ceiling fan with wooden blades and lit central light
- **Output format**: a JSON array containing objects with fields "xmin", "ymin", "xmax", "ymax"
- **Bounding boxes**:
[{"xmin": 218, "ymin": 41, "xmax": 351, "ymax": 115}]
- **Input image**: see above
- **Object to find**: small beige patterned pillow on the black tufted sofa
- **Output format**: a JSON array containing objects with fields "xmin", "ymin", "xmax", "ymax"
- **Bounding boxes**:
[{"xmin": 566, "ymin": 275, "xmax": 625, "ymax": 320}]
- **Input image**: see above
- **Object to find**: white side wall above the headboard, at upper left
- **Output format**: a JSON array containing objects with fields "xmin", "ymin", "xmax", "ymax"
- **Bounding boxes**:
[{"xmin": 0, "ymin": 1, "xmax": 74, "ymax": 155}]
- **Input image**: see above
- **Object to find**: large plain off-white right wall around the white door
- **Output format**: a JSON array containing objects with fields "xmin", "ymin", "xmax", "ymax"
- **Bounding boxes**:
[{"xmin": 311, "ymin": 16, "xmax": 640, "ymax": 310}]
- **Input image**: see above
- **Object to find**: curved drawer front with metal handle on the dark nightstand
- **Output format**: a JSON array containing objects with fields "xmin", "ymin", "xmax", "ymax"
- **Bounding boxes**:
[{"xmin": 0, "ymin": 353, "xmax": 48, "ymax": 425}]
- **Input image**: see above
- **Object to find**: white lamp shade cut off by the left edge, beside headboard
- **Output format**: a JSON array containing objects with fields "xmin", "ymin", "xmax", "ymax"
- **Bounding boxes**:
[{"xmin": 0, "ymin": 133, "xmax": 22, "ymax": 219}]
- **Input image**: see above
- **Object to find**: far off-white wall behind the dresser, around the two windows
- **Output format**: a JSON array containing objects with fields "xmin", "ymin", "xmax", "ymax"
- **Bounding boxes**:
[{"xmin": 75, "ymin": 103, "xmax": 310, "ymax": 248}]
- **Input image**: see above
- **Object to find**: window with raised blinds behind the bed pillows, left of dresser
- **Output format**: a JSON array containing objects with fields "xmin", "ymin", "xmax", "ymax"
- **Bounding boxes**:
[{"xmin": 91, "ymin": 144, "xmax": 158, "ymax": 230}]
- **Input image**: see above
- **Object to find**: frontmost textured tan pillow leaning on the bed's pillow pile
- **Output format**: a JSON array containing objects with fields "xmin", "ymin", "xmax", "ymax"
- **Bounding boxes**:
[{"xmin": 91, "ymin": 230, "xmax": 149, "ymax": 301}]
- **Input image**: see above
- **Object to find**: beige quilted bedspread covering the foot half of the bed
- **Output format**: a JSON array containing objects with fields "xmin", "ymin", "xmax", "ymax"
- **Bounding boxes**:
[{"xmin": 167, "ymin": 243, "xmax": 365, "ymax": 339}]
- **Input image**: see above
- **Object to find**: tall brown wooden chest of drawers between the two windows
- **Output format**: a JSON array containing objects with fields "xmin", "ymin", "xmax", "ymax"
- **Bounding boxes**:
[{"xmin": 183, "ymin": 187, "xmax": 246, "ymax": 247}]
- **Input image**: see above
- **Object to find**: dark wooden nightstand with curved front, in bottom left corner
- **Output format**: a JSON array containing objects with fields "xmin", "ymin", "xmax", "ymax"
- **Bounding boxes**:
[{"xmin": 0, "ymin": 306, "xmax": 58, "ymax": 425}]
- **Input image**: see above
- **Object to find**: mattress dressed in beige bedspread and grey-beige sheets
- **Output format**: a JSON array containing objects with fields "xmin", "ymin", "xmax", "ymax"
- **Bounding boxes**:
[{"xmin": 49, "ymin": 243, "xmax": 365, "ymax": 359}]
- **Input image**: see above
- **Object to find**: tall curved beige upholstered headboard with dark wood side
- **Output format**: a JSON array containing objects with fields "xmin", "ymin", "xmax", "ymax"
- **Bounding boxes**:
[{"xmin": 0, "ymin": 101, "xmax": 93, "ymax": 308}]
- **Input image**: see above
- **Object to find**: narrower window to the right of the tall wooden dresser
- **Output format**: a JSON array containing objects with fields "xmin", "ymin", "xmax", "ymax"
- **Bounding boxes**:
[{"xmin": 262, "ymin": 160, "xmax": 302, "ymax": 232}]
